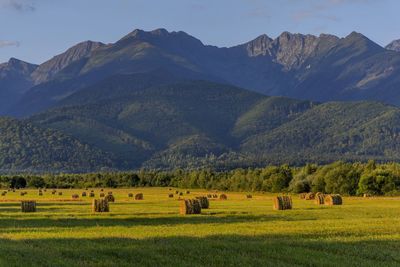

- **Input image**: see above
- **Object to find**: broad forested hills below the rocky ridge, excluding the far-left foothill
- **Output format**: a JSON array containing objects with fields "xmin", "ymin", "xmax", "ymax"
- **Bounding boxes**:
[{"xmin": 25, "ymin": 74, "xmax": 400, "ymax": 169}]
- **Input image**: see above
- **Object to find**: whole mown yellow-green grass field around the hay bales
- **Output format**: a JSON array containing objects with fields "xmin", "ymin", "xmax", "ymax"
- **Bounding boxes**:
[{"xmin": 0, "ymin": 188, "xmax": 400, "ymax": 266}]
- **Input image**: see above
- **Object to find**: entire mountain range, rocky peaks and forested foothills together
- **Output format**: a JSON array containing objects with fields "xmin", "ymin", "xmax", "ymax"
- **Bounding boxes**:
[{"xmin": 0, "ymin": 29, "xmax": 400, "ymax": 171}]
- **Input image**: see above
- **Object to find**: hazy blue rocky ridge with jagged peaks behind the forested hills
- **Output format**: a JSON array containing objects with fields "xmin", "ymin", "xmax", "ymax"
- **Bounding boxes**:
[{"xmin": 9, "ymin": 29, "xmax": 400, "ymax": 116}]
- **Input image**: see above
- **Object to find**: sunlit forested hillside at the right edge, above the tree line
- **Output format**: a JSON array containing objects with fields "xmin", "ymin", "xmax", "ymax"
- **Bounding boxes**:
[{"xmin": 241, "ymin": 102, "xmax": 400, "ymax": 162}]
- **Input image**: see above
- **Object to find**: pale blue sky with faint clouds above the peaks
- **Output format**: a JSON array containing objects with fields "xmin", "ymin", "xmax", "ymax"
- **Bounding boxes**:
[{"xmin": 0, "ymin": 0, "xmax": 400, "ymax": 63}]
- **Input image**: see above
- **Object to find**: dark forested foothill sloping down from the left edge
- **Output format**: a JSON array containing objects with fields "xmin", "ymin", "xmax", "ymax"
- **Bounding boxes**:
[{"xmin": 0, "ymin": 118, "xmax": 115, "ymax": 172}]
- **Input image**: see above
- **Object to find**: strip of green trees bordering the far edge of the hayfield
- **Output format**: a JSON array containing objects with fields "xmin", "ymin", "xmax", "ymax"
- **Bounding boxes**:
[{"xmin": 0, "ymin": 161, "xmax": 400, "ymax": 195}]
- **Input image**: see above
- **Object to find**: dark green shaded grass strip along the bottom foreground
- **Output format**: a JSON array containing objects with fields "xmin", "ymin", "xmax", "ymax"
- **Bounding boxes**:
[{"xmin": 0, "ymin": 234, "xmax": 400, "ymax": 266}]
